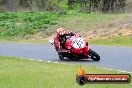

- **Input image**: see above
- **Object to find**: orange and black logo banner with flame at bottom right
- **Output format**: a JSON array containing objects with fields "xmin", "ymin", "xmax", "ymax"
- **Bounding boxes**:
[{"xmin": 76, "ymin": 66, "xmax": 131, "ymax": 85}]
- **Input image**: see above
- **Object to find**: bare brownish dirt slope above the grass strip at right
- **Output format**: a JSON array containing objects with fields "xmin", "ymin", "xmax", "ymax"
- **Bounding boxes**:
[{"xmin": 87, "ymin": 20, "xmax": 132, "ymax": 38}]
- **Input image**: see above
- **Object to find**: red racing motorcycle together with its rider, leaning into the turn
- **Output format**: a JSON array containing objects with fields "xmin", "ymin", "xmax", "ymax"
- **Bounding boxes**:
[{"xmin": 52, "ymin": 28, "xmax": 100, "ymax": 61}]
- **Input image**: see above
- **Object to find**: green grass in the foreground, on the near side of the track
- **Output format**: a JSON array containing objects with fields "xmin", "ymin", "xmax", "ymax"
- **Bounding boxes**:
[{"xmin": 0, "ymin": 56, "xmax": 132, "ymax": 88}]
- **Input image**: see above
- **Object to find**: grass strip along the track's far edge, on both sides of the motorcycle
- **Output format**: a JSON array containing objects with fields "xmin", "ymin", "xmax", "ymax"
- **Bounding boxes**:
[{"xmin": 0, "ymin": 36, "xmax": 132, "ymax": 47}]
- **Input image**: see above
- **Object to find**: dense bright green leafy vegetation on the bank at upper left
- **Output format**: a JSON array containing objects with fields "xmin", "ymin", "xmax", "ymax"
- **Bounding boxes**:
[{"xmin": 0, "ymin": 12, "xmax": 61, "ymax": 37}]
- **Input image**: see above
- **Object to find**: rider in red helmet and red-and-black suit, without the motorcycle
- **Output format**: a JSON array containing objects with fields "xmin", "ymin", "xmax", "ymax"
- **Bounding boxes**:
[{"xmin": 55, "ymin": 28, "xmax": 77, "ymax": 49}]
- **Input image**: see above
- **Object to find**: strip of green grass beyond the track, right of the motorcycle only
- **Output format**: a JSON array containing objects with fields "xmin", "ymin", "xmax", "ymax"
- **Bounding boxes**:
[{"xmin": 88, "ymin": 36, "xmax": 132, "ymax": 47}]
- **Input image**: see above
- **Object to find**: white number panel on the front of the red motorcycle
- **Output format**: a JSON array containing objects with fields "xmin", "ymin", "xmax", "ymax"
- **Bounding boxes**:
[{"xmin": 72, "ymin": 38, "xmax": 85, "ymax": 48}]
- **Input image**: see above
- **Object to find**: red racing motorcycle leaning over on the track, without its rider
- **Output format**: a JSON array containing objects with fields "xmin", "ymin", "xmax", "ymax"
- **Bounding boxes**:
[{"xmin": 49, "ymin": 35, "xmax": 100, "ymax": 61}]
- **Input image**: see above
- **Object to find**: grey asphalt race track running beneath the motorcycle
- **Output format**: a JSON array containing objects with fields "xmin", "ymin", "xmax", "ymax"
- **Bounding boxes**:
[{"xmin": 0, "ymin": 42, "xmax": 132, "ymax": 72}]
